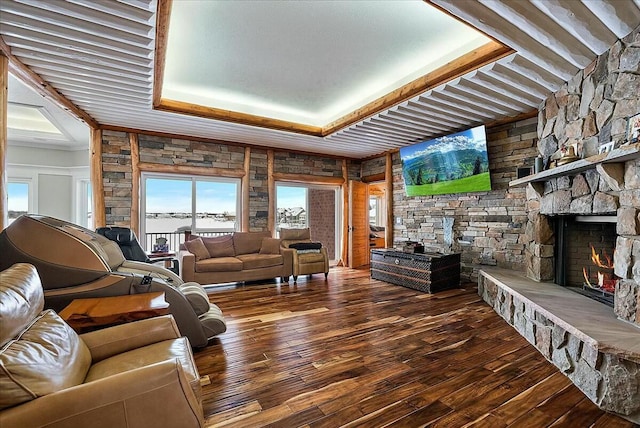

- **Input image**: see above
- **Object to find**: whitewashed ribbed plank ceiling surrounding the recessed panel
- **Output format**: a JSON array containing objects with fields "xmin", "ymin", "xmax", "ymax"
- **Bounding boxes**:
[{"xmin": 0, "ymin": 0, "xmax": 640, "ymax": 158}]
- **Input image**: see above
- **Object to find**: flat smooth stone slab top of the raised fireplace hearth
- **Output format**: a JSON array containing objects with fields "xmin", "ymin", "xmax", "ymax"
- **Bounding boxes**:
[{"xmin": 480, "ymin": 268, "xmax": 640, "ymax": 362}]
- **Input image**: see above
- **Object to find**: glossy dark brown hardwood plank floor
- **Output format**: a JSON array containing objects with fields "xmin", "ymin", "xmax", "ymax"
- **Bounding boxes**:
[{"xmin": 195, "ymin": 268, "xmax": 633, "ymax": 428}]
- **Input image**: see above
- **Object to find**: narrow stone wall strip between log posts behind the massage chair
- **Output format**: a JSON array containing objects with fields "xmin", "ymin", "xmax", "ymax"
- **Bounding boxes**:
[{"xmin": 102, "ymin": 131, "xmax": 133, "ymax": 227}]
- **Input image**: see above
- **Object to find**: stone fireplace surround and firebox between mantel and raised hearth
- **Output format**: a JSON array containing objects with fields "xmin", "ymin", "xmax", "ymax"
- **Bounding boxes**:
[{"xmin": 526, "ymin": 159, "xmax": 640, "ymax": 326}]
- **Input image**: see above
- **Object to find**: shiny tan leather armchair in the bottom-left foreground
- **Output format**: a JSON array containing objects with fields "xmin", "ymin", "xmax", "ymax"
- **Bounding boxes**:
[{"xmin": 0, "ymin": 263, "xmax": 204, "ymax": 428}]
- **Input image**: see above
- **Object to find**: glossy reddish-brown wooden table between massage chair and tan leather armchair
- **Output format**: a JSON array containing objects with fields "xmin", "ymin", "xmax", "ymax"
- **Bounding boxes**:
[{"xmin": 60, "ymin": 291, "xmax": 169, "ymax": 333}]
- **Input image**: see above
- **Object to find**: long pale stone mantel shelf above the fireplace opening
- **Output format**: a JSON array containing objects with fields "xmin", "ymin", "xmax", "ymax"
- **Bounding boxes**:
[{"xmin": 509, "ymin": 143, "xmax": 640, "ymax": 187}]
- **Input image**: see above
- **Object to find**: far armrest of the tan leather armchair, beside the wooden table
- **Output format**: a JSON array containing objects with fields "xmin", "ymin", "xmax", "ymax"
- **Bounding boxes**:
[{"xmin": 80, "ymin": 315, "xmax": 181, "ymax": 363}]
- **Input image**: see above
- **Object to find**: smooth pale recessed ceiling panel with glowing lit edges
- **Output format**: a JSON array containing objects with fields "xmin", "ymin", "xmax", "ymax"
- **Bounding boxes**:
[{"xmin": 162, "ymin": 0, "xmax": 490, "ymax": 126}]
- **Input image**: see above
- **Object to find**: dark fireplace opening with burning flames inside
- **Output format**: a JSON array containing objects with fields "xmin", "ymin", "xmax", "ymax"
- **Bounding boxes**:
[{"xmin": 555, "ymin": 216, "xmax": 618, "ymax": 307}]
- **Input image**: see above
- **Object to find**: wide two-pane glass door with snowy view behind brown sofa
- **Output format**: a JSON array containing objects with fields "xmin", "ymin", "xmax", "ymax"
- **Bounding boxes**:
[{"xmin": 140, "ymin": 173, "xmax": 240, "ymax": 251}]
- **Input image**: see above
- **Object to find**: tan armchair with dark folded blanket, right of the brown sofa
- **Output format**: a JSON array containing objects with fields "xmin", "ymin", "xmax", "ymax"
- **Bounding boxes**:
[{"xmin": 280, "ymin": 228, "xmax": 329, "ymax": 284}]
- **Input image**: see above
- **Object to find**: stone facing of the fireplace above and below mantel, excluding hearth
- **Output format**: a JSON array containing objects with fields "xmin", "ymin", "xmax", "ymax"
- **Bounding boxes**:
[{"xmin": 526, "ymin": 27, "xmax": 640, "ymax": 324}]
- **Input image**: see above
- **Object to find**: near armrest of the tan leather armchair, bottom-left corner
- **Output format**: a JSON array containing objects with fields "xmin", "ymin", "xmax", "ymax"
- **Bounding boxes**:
[{"xmin": 0, "ymin": 360, "xmax": 204, "ymax": 428}]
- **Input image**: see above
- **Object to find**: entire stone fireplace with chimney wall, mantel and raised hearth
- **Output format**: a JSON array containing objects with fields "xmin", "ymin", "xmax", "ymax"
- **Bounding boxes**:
[{"xmin": 478, "ymin": 28, "xmax": 640, "ymax": 424}]
